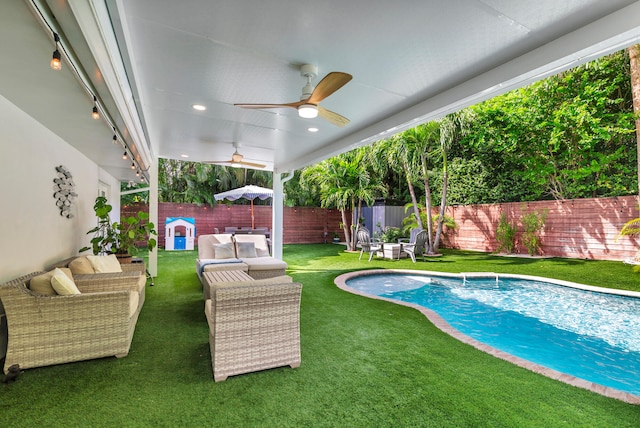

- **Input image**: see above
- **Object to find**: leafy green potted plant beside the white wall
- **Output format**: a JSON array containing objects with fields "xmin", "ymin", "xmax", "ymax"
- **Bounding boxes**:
[{"xmin": 80, "ymin": 196, "xmax": 157, "ymax": 263}]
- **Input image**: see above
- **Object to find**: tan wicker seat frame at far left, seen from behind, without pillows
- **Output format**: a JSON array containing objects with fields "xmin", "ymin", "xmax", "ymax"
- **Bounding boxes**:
[{"xmin": 0, "ymin": 272, "xmax": 141, "ymax": 372}]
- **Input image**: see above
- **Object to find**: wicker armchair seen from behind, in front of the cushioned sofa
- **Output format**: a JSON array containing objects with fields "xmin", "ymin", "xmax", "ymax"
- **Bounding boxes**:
[{"xmin": 205, "ymin": 281, "xmax": 302, "ymax": 382}]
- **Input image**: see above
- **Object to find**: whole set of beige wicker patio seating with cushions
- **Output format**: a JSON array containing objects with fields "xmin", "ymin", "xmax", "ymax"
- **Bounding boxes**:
[{"xmin": 0, "ymin": 234, "xmax": 302, "ymax": 381}]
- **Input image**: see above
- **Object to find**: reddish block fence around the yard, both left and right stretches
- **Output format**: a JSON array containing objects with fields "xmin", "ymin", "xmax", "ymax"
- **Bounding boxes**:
[{"xmin": 121, "ymin": 196, "xmax": 640, "ymax": 260}]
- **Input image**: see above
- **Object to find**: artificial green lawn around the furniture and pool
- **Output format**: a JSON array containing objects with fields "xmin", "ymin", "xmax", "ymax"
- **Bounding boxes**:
[{"xmin": 0, "ymin": 244, "xmax": 640, "ymax": 427}]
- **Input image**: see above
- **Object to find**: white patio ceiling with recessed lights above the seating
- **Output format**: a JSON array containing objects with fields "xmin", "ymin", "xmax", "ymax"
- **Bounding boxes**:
[{"xmin": 0, "ymin": 0, "xmax": 640, "ymax": 180}]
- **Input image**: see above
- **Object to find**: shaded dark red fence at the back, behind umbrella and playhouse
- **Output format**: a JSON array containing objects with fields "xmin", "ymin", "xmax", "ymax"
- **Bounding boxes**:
[{"xmin": 120, "ymin": 202, "xmax": 344, "ymax": 247}]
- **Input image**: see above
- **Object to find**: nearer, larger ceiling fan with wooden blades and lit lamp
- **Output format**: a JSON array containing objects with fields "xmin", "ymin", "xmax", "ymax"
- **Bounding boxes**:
[{"xmin": 234, "ymin": 64, "xmax": 352, "ymax": 126}]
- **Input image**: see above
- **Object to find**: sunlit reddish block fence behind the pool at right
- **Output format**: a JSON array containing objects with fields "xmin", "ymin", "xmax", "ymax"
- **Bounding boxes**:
[{"xmin": 444, "ymin": 196, "xmax": 640, "ymax": 260}]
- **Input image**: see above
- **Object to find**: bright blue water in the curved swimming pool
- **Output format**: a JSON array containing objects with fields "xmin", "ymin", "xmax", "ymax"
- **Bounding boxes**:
[{"xmin": 347, "ymin": 274, "xmax": 640, "ymax": 395}]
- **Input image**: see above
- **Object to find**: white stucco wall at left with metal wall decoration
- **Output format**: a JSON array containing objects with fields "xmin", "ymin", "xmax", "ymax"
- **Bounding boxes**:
[{"xmin": 0, "ymin": 92, "xmax": 120, "ymax": 283}]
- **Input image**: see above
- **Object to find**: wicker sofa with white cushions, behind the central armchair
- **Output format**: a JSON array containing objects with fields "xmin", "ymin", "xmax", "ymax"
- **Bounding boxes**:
[{"xmin": 196, "ymin": 233, "xmax": 287, "ymax": 287}]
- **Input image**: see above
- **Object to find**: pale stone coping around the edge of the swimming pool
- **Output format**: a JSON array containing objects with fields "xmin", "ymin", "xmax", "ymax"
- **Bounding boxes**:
[{"xmin": 334, "ymin": 269, "xmax": 640, "ymax": 404}]
